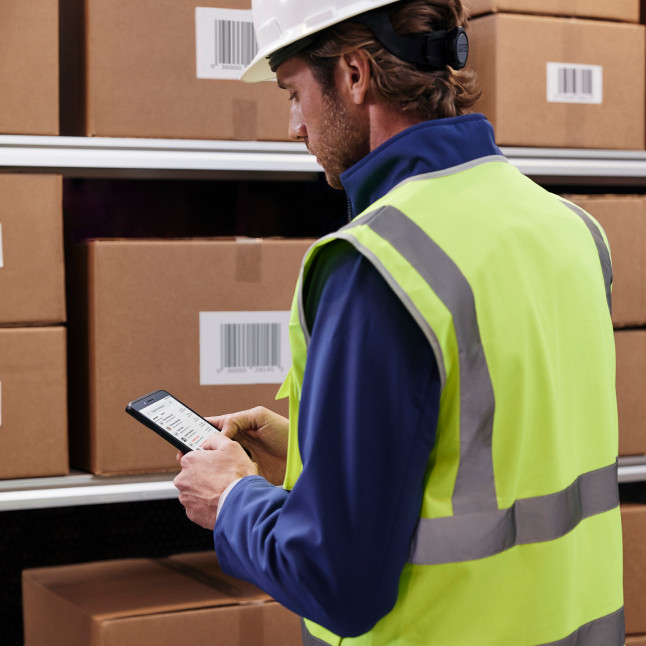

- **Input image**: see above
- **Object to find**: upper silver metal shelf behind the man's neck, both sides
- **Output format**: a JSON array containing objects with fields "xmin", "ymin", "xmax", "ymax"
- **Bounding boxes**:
[{"xmin": 0, "ymin": 135, "xmax": 646, "ymax": 186}]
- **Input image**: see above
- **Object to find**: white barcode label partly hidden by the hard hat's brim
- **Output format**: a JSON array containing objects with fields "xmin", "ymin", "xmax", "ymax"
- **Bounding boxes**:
[{"xmin": 195, "ymin": 7, "xmax": 258, "ymax": 80}]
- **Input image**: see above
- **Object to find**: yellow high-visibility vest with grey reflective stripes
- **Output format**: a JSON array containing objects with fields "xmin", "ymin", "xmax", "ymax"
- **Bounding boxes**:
[{"xmin": 281, "ymin": 156, "xmax": 624, "ymax": 646}]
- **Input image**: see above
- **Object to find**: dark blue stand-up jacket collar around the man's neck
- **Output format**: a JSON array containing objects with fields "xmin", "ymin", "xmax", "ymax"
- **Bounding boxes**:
[{"xmin": 341, "ymin": 114, "xmax": 502, "ymax": 217}]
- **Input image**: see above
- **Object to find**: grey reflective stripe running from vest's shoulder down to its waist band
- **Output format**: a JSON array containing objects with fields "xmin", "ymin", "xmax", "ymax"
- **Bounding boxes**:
[{"xmin": 344, "ymin": 206, "xmax": 498, "ymax": 514}]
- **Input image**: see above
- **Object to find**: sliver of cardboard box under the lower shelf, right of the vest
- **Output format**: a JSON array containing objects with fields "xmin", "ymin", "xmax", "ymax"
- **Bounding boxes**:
[{"xmin": 621, "ymin": 503, "xmax": 646, "ymax": 644}]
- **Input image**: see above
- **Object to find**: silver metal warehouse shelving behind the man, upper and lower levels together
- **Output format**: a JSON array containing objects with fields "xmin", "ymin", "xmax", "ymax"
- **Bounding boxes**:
[{"xmin": 0, "ymin": 135, "xmax": 646, "ymax": 511}]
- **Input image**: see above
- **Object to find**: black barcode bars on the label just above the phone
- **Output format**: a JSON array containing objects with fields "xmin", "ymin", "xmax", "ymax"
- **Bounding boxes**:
[{"xmin": 220, "ymin": 323, "xmax": 281, "ymax": 369}]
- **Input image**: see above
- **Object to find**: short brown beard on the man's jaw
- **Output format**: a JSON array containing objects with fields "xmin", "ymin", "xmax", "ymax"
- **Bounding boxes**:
[{"xmin": 310, "ymin": 90, "xmax": 370, "ymax": 190}]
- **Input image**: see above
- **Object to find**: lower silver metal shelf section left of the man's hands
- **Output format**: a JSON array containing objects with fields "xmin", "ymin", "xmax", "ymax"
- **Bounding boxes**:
[{"xmin": 0, "ymin": 472, "xmax": 179, "ymax": 512}]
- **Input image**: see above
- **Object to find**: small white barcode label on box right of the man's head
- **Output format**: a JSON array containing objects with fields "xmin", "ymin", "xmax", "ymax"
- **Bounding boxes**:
[{"xmin": 547, "ymin": 63, "xmax": 603, "ymax": 103}]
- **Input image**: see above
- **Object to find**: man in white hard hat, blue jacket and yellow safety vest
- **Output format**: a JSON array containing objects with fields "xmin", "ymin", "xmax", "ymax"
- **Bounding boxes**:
[{"xmin": 175, "ymin": 0, "xmax": 624, "ymax": 646}]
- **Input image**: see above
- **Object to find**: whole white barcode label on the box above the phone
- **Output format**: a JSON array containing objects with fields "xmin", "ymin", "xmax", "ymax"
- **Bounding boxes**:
[{"xmin": 200, "ymin": 311, "xmax": 291, "ymax": 386}]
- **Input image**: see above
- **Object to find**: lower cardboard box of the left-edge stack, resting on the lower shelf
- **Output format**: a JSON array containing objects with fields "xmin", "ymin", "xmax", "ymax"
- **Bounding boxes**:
[{"xmin": 0, "ymin": 327, "xmax": 68, "ymax": 479}]
